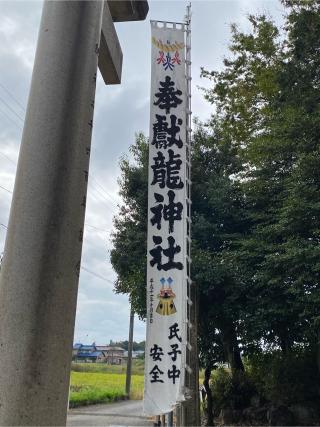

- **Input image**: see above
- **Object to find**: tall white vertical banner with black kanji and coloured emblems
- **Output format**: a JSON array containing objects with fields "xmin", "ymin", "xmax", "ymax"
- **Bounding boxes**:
[{"xmin": 144, "ymin": 21, "xmax": 189, "ymax": 415}]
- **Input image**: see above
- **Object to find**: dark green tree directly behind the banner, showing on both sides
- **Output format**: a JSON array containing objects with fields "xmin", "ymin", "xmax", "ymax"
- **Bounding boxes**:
[{"xmin": 111, "ymin": 125, "xmax": 246, "ymax": 370}]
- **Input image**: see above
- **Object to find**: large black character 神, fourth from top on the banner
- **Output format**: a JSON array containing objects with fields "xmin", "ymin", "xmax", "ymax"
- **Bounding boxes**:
[{"xmin": 150, "ymin": 190, "xmax": 183, "ymax": 233}]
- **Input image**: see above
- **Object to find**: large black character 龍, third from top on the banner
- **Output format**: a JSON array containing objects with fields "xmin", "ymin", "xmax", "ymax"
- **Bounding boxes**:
[{"xmin": 151, "ymin": 150, "xmax": 184, "ymax": 190}]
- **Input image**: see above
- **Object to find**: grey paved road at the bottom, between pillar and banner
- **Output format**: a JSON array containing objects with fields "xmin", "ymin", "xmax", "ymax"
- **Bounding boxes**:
[{"xmin": 67, "ymin": 400, "xmax": 153, "ymax": 427}]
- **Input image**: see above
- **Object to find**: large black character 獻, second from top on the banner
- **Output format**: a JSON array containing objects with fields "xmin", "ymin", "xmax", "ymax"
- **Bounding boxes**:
[{"xmin": 151, "ymin": 114, "xmax": 183, "ymax": 148}]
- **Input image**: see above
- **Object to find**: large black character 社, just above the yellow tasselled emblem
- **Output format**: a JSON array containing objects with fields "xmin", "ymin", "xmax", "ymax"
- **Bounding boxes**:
[{"xmin": 149, "ymin": 236, "xmax": 183, "ymax": 271}]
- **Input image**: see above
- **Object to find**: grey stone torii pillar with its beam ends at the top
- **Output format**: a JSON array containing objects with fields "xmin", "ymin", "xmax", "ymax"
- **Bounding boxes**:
[{"xmin": 0, "ymin": 0, "xmax": 148, "ymax": 426}]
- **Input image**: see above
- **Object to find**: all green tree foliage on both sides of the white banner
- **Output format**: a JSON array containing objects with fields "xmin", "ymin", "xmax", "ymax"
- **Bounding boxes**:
[{"xmin": 111, "ymin": 0, "xmax": 320, "ymax": 382}]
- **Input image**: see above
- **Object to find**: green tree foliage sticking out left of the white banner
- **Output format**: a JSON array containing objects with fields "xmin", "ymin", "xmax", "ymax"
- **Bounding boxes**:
[{"xmin": 111, "ymin": 133, "xmax": 148, "ymax": 319}]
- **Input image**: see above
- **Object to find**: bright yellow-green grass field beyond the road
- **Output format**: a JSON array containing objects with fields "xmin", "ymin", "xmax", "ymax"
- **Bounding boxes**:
[{"xmin": 69, "ymin": 361, "xmax": 144, "ymax": 408}]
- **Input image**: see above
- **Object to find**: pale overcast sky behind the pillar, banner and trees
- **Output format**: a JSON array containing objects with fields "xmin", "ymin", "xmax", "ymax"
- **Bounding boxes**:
[{"xmin": 0, "ymin": 0, "xmax": 284, "ymax": 344}]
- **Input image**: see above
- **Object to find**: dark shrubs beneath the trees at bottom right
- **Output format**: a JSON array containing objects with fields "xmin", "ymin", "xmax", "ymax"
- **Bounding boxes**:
[{"xmin": 211, "ymin": 348, "xmax": 320, "ymax": 414}]
